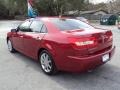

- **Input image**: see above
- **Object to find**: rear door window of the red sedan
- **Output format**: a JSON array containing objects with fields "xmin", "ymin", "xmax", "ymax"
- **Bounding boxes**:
[{"xmin": 30, "ymin": 21, "xmax": 43, "ymax": 32}]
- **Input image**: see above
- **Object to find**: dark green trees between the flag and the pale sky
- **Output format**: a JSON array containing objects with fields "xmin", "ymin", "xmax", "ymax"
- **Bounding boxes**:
[{"xmin": 35, "ymin": 0, "xmax": 86, "ymax": 15}]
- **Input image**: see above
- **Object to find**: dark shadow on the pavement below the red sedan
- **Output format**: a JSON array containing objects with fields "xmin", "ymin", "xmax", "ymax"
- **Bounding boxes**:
[{"xmin": 10, "ymin": 50, "xmax": 120, "ymax": 90}]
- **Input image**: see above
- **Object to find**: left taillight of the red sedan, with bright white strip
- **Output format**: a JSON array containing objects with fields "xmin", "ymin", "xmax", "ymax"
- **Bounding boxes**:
[{"xmin": 69, "ymin": 37, "xmax": 97, "ymax": 49}]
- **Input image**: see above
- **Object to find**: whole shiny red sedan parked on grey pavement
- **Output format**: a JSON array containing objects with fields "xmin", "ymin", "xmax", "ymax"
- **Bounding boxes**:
[{"xmin": 7, "ymin": 17, "xmax": 115, "ymax": 75}]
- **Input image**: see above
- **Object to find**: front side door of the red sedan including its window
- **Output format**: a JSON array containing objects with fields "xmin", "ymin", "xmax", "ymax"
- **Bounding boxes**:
[{"xmin": 12, "ymin": 21, "xmax": 31, "ymax": 52}]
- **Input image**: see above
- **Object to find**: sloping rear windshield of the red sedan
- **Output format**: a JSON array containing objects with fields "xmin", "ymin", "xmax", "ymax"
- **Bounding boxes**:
[{"xmin": 51, "ymin": 19, "xmax": 93, "ymax": 31}]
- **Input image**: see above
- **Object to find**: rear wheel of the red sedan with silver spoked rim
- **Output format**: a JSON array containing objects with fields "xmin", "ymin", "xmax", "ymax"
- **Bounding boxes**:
[{"xmin": 39, "ymin": 50, "xmax": 57, "ymax": 75}]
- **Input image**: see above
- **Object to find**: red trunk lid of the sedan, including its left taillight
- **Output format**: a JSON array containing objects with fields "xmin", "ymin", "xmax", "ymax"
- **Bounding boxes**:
[{"xmin": 62, "ymin": 28, "xmax": 113, "ymax": 55}]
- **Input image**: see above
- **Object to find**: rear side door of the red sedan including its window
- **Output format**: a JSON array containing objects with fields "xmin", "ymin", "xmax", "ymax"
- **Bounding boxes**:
[{"xmin": 23, "ymin": 20, "xmax": 47, "ymax": 59}]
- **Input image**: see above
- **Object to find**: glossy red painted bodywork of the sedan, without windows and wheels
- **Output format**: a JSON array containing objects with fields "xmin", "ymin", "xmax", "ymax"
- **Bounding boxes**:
[{"xmin": 7, "ymin": 17, "xmax": 115, "ymax": 72}]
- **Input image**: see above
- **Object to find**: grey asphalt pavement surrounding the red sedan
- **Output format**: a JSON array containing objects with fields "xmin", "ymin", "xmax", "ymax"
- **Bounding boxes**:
[{"xmin": 0, "ymin": 21, "xmax": 120, "ymax": 90}]
